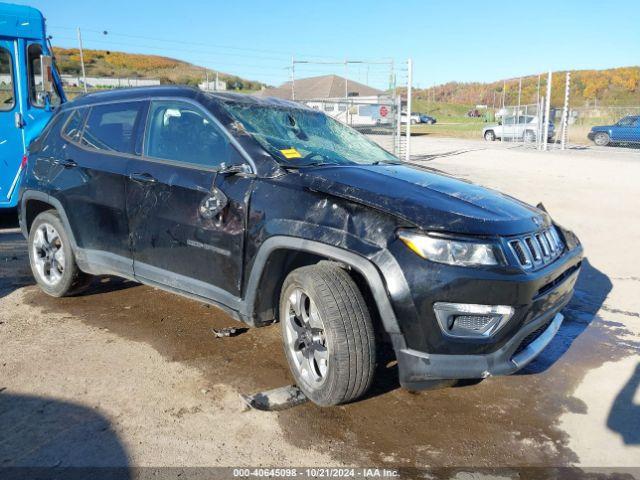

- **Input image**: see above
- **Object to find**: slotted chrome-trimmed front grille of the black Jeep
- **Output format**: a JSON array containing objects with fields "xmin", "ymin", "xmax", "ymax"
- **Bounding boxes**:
[{"xmin": 509, "ymin": 227, "xmax": 564, "ymax": 269}]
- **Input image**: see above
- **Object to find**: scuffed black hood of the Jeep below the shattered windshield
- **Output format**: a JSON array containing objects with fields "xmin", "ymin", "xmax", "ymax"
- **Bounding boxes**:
[{"xmin": 302, "ymin": 165, "xmax": 550, "ymax": 235}]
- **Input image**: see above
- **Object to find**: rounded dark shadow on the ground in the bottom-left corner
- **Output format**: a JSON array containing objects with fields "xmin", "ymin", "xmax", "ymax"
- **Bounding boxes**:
[{"xmin": 0, "ymin": 392, "xmax": 129, "ymax": 472}]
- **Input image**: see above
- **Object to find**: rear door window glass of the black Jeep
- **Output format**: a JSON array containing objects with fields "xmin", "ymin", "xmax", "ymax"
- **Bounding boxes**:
[{"xmin": 81, "ymin": 102, "xmax": 144, "ymax": 154}]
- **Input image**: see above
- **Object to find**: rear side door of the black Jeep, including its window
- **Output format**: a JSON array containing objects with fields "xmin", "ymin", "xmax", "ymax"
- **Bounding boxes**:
[{"xmin": 51, "ymin": 101, "xmax": 148, "ymax": 274}]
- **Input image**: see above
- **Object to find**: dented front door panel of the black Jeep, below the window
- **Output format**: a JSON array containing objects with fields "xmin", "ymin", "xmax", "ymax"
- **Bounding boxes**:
[{"xmin": 126, "ymin": 154, "xmax": 252, "ymax": 296}]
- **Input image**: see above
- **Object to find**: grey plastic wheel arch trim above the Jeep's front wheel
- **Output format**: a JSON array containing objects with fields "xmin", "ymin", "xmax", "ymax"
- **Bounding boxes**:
[{"xmin": 242, "ymin": 236, "xmax": 400, "ymax": 334}]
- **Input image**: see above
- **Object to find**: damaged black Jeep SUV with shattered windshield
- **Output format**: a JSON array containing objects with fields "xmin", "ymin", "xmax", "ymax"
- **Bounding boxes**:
[{"xmin": 20, "ymin": 87, "xmax": 582, "ymax": 405}]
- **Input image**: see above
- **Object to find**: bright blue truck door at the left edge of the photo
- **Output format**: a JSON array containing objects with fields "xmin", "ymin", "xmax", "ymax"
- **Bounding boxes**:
[{"xmin": 0, "ymin": 37, "xmax": 25, "ymax": 208}]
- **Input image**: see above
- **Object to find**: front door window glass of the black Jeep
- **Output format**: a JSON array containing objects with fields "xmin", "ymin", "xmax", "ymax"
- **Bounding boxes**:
[{"xmin": 144, "ymin": 101, "xmax": 229, "ymax": 167}]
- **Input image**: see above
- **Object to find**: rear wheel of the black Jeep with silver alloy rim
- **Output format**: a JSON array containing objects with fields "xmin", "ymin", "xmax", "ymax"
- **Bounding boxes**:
[{"xmin": 29, "ymin": 210, "xmax": 91, "ymax": 297}]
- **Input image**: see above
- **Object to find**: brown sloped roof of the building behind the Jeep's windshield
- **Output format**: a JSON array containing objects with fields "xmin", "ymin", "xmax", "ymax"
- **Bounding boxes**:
[{"xmin": 256, "ymin": 75, "xmax": 383, "ymax": 100}]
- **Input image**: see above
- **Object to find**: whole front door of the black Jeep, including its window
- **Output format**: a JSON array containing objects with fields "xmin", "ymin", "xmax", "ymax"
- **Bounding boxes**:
[{"xmin": 127, "ymin": 100, "xmax": 252, "ymax": 307}]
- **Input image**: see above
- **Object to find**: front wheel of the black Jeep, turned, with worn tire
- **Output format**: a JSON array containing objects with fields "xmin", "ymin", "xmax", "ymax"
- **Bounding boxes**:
[{"xmin": 279, "ymin": 262, "xmax": 376, "ymax": 406}]
